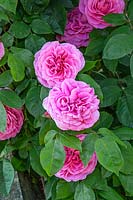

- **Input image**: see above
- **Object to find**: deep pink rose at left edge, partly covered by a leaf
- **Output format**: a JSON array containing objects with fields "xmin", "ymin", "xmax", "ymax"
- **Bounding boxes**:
[{"xmin": 0, "ymin": 106, "xmax": 24, "ymax": 140}]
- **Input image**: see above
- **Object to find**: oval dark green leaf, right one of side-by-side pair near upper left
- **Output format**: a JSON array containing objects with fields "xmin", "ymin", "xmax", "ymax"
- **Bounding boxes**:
[{"xmin": 31, "ymin": 19, "xmax": 53, "ymax": 34}]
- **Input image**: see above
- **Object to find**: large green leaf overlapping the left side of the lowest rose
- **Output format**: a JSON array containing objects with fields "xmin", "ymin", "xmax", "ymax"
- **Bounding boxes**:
[{"xmin": 40, "ymin": 138, "xmax": 65, "ymax": 176}]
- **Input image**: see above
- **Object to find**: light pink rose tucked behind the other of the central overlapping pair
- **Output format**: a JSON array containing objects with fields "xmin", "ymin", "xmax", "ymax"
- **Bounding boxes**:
[{"xmin": 34, "ymin": 41, "xmax": 85, "ymax": 88}]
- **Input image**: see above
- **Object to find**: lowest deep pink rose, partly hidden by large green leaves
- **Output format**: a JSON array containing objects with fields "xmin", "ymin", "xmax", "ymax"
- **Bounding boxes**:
[{"xmin": 55, "ymin": 135, "xmax": 97, "ymax": 182}]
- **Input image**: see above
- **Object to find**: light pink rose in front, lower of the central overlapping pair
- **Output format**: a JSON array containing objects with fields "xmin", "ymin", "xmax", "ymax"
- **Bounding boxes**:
[{"xmin": 43, "ymin": 79, "xmax": 99, "ymax": 131}]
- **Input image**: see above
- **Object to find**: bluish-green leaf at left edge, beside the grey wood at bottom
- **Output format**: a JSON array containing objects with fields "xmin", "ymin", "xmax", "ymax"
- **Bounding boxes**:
[{"xmin": 0, "ymin": 159, "xmax": 14, "ymax": 196}]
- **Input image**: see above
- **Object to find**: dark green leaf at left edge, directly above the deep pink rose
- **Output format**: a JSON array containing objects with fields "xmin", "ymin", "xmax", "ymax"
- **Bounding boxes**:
[{"xmin": 0, "ymin": 89, "xmax": 23, "ymax": 108}]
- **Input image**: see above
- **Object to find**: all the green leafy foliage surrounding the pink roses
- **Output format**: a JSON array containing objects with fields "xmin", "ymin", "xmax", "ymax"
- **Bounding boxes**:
[{"xmin": 0, "ymin": 0, "xmax": 133, "ymax": 200}]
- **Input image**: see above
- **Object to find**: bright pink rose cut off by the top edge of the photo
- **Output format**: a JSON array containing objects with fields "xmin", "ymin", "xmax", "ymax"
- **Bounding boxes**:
[{"xmin": 79, "ymin": 0, "xmax": 125, "ymax": 29}]
